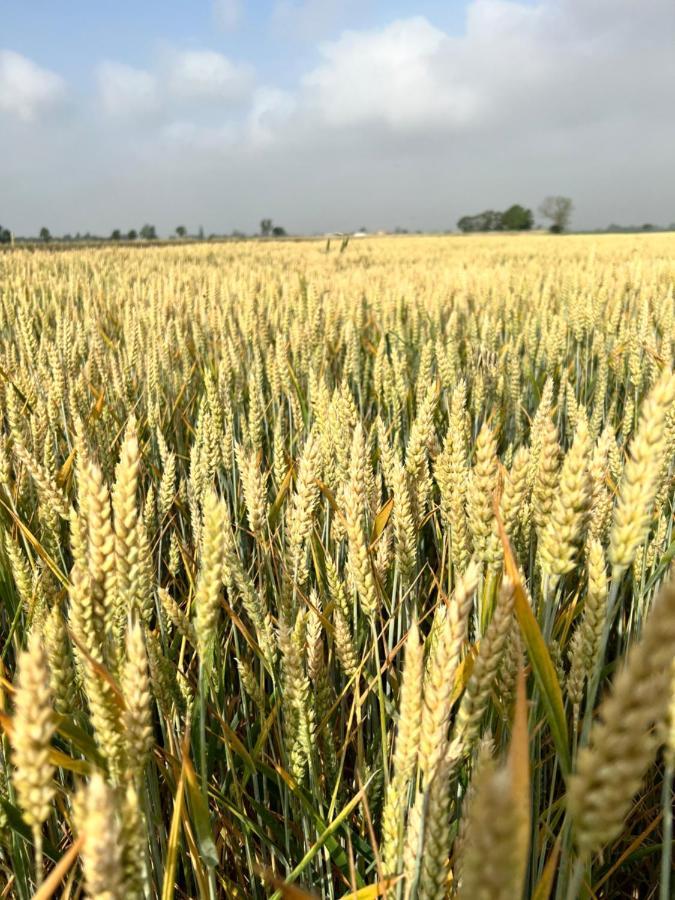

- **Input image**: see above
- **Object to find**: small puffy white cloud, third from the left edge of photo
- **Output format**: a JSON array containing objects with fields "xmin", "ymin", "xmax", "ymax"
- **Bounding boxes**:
[{"xmin": 167, "ymin": 50, "xmax": 253, "ymax": 102}]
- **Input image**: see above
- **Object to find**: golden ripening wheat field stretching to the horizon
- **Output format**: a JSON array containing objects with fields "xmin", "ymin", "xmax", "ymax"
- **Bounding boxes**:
[{"xmin": 0, "ymin": 235, "xmax": 675, "ymax": 900}]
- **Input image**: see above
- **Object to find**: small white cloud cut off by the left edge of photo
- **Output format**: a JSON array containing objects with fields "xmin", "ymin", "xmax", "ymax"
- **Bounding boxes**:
[{"xmin": 0, "ymin": 50, "xmax": 66, "ymax": 122}]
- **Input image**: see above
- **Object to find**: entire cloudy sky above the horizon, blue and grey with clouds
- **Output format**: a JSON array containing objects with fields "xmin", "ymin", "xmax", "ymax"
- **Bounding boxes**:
[{"xmin": 0, "ymin": 0, "xmax": 675, "ymax": 234}]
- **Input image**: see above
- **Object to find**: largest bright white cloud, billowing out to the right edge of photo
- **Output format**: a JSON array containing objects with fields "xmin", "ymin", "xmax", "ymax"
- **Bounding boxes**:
[{"xmin": 301, "ymin": 0, "xmax": 675, "ymax": 139}]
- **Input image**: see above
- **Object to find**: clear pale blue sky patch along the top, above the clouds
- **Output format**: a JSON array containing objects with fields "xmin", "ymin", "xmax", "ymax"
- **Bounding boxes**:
[{"xmin": 0, "ymin": 0, "xmax": 466, "ymax": 91}]
